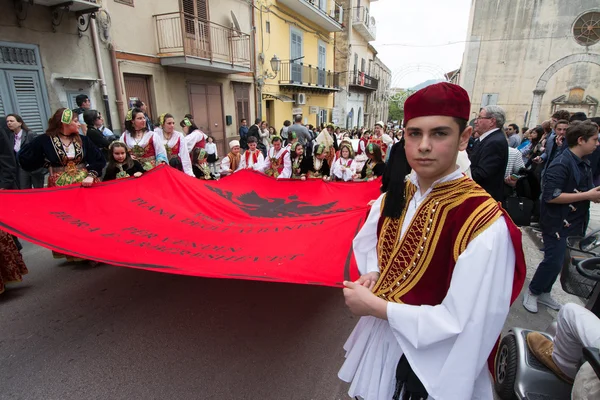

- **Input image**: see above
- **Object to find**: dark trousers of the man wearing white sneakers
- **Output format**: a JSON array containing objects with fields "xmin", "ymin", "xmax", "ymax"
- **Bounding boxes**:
[{"xmin": 529, "ymin": 233, "xmax": 567, "ymax": 296}]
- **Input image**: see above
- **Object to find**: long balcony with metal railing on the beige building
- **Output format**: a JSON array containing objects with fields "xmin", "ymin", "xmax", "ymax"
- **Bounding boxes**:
[{"xmin": 154, "ymin": 12, "xmax": 252, "ymax": 74}]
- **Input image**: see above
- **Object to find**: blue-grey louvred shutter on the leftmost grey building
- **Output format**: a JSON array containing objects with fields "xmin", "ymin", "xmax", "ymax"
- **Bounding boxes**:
[{"xmin": 6, "ymin": 71, "xmax": 48, "ymax": 133}]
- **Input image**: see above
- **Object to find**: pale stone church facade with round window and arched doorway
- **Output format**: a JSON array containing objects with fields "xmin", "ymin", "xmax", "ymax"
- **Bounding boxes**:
[{"xmin": 458, "ymin": 0, "xmax": 600, "ymax": 126}]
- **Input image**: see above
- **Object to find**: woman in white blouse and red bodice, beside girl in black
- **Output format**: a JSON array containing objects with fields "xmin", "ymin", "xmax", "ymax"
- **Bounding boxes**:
[{"xmin": 119, "ymin": 108, "xmax": 168, "ymax": 171}]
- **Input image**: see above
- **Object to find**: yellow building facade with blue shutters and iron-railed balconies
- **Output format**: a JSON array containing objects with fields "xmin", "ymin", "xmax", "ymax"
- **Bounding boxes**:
[{"xmin": 255, "ymin": 0, "xmax": 343, "ymax": 132}]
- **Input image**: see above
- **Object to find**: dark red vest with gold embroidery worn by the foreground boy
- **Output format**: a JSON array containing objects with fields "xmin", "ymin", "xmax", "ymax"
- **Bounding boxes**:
[{"xmin": 373, "ymin": 177, "xmax": 526, "ymax": 375}]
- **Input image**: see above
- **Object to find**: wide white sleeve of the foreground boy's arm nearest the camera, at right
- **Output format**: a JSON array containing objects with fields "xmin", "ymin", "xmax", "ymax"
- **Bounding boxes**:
[{"xmin": 387, "ymin": 217, "xmax": 515, "ymax": 399}]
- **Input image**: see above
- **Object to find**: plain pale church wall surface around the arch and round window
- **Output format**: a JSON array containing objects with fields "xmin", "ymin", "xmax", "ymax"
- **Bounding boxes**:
[{"xmin": 460, "ymin": 0, "xmax": 600, "ymax": 125}]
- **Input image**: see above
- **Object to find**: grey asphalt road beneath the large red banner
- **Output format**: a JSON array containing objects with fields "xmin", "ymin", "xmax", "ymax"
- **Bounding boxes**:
[{"xmin": 0, "ymin": 244, "xmax": 357, "ymax": 400}]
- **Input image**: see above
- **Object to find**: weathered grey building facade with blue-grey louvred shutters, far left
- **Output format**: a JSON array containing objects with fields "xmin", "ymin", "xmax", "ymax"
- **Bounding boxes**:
[{"xmin": 0, "ymin": 0, "xmax": 107, "ymax": 133}]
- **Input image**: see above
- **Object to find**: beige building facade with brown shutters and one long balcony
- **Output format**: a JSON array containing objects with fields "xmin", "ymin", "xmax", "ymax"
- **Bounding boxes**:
[{"xmin": 110, "ymin": 0, "xmax": 255, "ymax": 154}]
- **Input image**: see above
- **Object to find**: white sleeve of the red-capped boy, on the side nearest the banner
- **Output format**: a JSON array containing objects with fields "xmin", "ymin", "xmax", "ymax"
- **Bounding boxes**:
[{"xmin": 352, "ymin": 194, "xmax": 383, "ymax": 275}]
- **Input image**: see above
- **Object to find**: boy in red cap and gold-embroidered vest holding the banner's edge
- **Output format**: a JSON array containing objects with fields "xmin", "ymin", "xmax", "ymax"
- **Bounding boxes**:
[{"xmin": 339, "ymin": 82, "xmax": 525, "ymax": 400}]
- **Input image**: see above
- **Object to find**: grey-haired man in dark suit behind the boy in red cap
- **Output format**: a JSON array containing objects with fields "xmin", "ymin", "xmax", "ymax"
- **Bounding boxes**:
[{"xmin": 469, "ymin": 106, "xmax": 508, "ymax": 201}]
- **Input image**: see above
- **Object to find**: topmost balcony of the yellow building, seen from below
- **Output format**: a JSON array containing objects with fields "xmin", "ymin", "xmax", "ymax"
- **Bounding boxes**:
[{"xmin": 277, "ymin": 0, "xmax": 344, "ymax": 32}]
